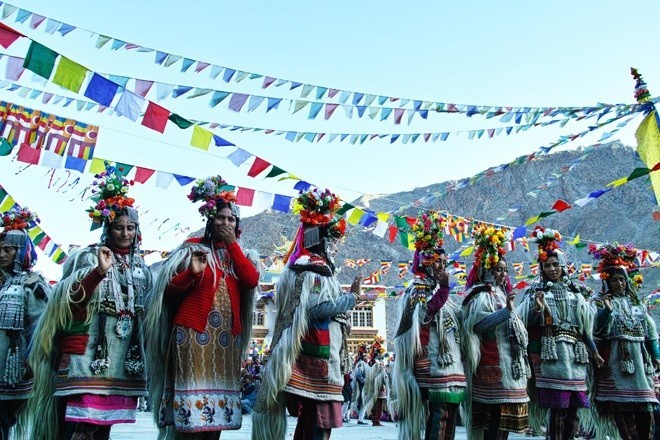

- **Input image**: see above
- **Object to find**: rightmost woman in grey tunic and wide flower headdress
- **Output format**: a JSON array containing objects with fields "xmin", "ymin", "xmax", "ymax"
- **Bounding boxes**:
[{"xmin": 589, "ymin": 243, "xmax": 660, "ymax": 440}]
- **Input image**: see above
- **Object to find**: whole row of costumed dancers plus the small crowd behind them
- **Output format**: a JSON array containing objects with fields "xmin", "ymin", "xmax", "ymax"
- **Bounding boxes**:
[{"xmin": 0, "ymin": 165, "xmax": 660, "ymax": 440}]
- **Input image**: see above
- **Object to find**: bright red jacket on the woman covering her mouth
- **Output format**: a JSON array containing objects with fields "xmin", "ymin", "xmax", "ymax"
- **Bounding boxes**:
[{"xmin": 165, "ymin": 238, "xmax": 259, "ymax": 336}]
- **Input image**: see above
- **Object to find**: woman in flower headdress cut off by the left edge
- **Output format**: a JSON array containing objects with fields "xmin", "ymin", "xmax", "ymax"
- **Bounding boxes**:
[{"xmin": 0, "ymin": 208, "xmax": 50, "ymax": 440}]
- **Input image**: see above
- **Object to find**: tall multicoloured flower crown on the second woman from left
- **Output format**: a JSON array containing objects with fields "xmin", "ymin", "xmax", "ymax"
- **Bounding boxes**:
[{"xmin": 87, "ymin": 162, "xmax": 135, "ymax": 228}]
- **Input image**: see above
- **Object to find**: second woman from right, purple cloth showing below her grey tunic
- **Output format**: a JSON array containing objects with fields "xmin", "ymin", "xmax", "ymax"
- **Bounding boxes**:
[{"xmin": 519, "ymin": 226, "xmax": 603, "ymax": 440}]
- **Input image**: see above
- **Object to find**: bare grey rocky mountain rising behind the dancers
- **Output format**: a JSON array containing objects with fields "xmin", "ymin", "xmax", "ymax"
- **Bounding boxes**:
[{"xmin": 235, "ymin": 142, "xmax": 660, "ymax": 349}]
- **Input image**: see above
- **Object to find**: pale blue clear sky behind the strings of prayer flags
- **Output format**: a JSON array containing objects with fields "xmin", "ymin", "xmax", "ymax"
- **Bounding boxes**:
[{"xmin": 0, "ymin": 0, "xmax": 660, "ymax": 273}]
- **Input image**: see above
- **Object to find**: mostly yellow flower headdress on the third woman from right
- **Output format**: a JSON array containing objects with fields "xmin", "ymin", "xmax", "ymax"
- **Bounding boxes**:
[{"xmin": 466, "ymin": 224, "xmax": 508, "ymax": 287}]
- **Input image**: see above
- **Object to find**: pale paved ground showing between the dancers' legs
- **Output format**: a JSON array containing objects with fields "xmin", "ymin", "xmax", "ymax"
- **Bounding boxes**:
[{"xmin": 111, "ymin": 412, "xmax": 541, "ymax": 440}]
